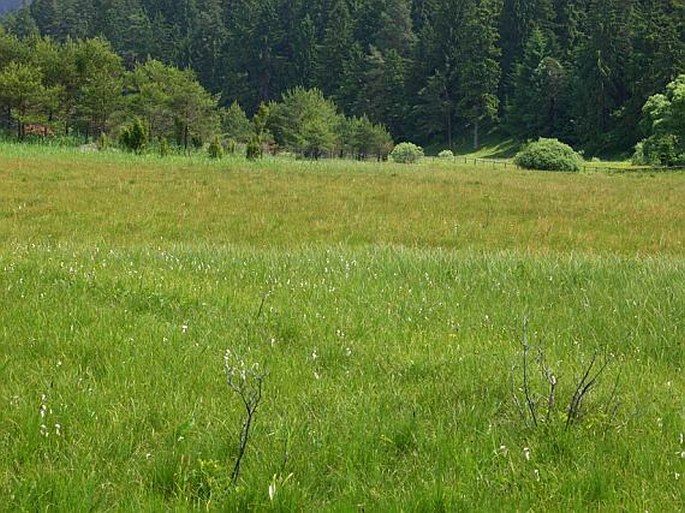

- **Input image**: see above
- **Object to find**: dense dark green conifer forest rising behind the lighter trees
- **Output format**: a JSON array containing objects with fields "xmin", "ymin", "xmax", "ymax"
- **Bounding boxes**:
[{"xmin": 0, "ymin": 0, "xmax": 685, "ymax": 155}]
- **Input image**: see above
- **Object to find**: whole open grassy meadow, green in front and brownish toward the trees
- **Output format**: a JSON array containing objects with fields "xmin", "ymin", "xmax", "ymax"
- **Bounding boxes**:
[{"xmin": 0, "ymin": 145, "xmax": 685, "ymax": 512}]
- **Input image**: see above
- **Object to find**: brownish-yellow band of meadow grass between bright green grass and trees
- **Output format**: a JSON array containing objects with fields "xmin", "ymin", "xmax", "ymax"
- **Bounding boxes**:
[{"xmin": 0, "ymin": 141, "xmax": 685, "ymax": 255}]
